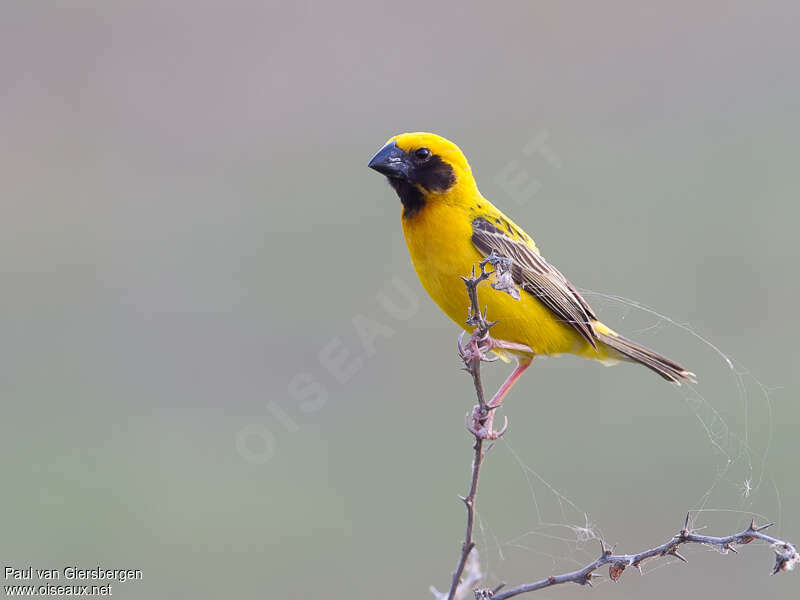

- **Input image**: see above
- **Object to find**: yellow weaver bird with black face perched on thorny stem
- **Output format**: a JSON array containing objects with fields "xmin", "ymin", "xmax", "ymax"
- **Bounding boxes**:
[{"xmin": 369, "ymin": 133, "xmax": 694, "ymax": 437}]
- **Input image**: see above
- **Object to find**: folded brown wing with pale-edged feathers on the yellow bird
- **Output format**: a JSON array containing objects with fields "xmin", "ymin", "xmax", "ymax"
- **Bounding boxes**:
[{"xmin": 472, "ymin": 217, "xmax": 597, "ymax": 348}]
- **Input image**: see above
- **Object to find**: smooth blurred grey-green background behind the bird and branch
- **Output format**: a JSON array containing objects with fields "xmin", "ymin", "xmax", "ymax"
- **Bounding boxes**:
[{"xmin": 0, "ymin": 0, "xmax": 800, "ymax": 599}]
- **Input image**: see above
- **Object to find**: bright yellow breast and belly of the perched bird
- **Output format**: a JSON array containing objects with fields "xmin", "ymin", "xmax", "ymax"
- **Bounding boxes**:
[{"xmin": 403, "ymin": 202, "xmax": 592, "ymax": 359}]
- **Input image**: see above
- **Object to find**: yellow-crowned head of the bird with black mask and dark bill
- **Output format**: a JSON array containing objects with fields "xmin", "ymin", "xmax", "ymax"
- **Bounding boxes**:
[{"xmin": 368, "ymin": 132, "xmax": 474, "ymax": 218}]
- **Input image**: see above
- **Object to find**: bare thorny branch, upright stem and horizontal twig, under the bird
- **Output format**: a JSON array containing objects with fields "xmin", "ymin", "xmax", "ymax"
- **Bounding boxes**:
[{"xmin": 431, "ymin": 254, "xmax": 800, "ymax": 600}]
